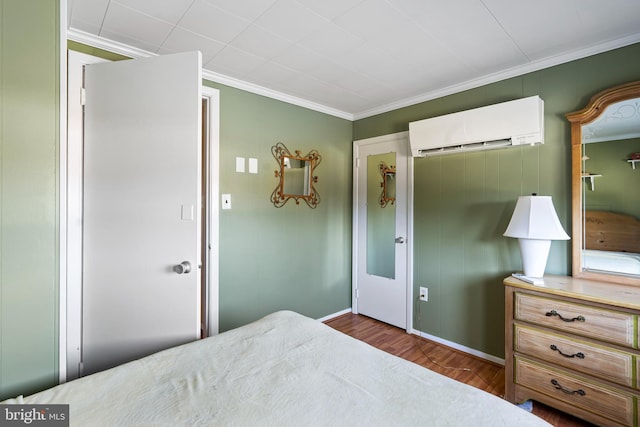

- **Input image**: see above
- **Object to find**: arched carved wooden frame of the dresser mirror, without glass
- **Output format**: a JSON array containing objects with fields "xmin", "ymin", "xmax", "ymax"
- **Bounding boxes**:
[{"xmin": 565, "ymin": 81, "xmax": 640, "ymax": 286}]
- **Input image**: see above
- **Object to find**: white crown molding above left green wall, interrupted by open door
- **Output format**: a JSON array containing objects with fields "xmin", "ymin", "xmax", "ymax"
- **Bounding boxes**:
[{"xmin": 67, "ymin": 28, "xmax": 354, "ymax": 121}]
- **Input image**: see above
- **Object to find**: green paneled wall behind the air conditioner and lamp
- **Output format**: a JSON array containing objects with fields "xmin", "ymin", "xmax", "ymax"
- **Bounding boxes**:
[{"xmin": 354, "ymin": 44, "xmax": 640, "ymax": 357}]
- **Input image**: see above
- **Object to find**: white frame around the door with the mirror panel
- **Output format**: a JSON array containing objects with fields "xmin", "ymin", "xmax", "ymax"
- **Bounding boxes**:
[{"xmin": 351, "ymin": 131, "xmax": 413, "ymax": 333}]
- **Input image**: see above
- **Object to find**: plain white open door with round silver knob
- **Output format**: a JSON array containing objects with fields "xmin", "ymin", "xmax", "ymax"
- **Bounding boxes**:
[{"xmin": 82, "ymin": 52, "xmax": 202, "ymax": 375}]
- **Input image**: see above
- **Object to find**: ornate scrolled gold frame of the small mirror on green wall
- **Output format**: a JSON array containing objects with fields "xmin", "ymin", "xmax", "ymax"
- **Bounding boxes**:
[{"xmin": 271, "ymin": 142, "xmax": 322, "ymax": 209}]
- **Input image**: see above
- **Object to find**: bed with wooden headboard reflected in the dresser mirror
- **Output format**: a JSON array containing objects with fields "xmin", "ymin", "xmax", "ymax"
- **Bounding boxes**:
[{"xmin": 582, "ymin": 210, "xmax": 640, "ymax": 275}]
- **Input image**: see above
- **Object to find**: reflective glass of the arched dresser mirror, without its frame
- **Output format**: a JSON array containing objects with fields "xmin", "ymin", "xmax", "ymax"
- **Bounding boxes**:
[{"xmin": 582, "ymin": 113, "xmax": 640, "ymax": 275}]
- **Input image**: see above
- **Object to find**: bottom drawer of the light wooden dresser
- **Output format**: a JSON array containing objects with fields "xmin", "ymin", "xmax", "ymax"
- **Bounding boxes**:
[{"xmin": 515, "ymin": 357, "xmax": 635, "ymax": 426}]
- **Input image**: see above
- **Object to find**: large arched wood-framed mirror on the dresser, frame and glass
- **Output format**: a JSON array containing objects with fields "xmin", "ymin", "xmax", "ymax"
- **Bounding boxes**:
[{"xmin": 566, "ymin": 81, "xmax": 640, "ymax": 285}]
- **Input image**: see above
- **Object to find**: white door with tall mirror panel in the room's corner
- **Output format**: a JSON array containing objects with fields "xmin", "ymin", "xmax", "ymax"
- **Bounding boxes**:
[{"xmin": 353, "ymin": 133, "xmax": 410, "ymax": 329}]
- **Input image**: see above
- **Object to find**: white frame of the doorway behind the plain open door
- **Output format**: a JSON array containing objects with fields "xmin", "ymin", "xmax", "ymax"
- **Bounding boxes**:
[{"xmin": 59, "ymin": 51, "xmax": 220, "ymax": 382}]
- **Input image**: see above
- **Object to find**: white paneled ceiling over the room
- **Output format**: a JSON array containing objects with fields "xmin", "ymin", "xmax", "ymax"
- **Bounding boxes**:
[{"xmin": 67, "ymin": 0, "xmax": 640, "ymax": 119}]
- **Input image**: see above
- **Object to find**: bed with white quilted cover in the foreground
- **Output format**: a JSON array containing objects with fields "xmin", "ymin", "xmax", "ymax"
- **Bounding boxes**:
[{"xmin": 2, "ymin": 311, "xmax": 549, "ymax": 427}]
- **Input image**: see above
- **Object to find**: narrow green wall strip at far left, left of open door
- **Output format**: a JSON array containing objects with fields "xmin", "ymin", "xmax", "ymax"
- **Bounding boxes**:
[{"xmin": 0, "ymin": 0, "xmax": 60, "ymax": 400}]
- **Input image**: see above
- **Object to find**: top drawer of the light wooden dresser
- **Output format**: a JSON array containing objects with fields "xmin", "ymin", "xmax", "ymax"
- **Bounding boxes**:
[{"xmin": 514, "ymin": 292, "xmax": 634, "ymax": 347}]
